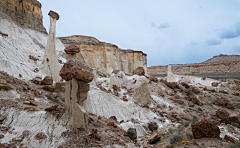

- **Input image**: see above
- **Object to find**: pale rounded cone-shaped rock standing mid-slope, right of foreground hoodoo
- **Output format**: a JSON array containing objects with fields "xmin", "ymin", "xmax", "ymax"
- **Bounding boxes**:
[{"xmin": 133, "ymin": 76, "xmax": 151, "ymax": 104}]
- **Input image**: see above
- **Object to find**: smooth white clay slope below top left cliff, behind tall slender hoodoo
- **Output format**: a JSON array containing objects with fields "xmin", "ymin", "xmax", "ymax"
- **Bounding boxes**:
[{"xmin": 0, "ymin": 15, "xmax": 65, "ymax": 79}]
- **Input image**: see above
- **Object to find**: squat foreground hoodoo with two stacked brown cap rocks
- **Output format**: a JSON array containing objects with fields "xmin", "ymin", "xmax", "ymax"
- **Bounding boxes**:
[{"xmin": 59, "ymin": 46, "xmax": 94, "ymax": 133}]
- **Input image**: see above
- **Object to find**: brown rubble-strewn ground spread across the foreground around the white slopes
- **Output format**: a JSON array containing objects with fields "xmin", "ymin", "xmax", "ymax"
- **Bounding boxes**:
[{"xmin": 0, "ymin": 69, "xmax": 240, "ymax": 148}]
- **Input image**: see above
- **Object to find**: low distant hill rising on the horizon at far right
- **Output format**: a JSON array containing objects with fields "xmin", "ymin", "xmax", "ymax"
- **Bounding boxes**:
[{"xmin": 202, "ymin": 54, "xmax": 240, "ymax": 63}]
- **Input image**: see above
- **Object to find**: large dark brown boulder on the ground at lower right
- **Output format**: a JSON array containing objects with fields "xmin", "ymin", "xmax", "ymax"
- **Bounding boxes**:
[{"xmin": 192, "ymin": 120, "xmax": 220, "ymax": 139}]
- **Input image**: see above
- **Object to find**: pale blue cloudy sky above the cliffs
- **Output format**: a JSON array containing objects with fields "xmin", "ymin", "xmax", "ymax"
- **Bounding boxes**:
[{"xmin": 40, "ymin": 0, "xmax": 240, "ymax": 66}]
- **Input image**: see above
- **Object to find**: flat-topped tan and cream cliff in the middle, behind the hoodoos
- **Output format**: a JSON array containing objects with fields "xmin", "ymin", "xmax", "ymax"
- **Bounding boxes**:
[{"xmin": 60, "ymin": 35, "xmax": 147, "ymax": 73}]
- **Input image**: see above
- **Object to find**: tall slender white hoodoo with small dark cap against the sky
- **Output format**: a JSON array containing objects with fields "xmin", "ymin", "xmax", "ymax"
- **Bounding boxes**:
[{"xmin": 42, "ymin": 11, "xmax": 61, "ymax": 82}]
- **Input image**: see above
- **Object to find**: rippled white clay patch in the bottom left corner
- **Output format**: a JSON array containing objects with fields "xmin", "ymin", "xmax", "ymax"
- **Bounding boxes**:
[{"xmin": 0, "ymin": 108, "xmax": 66, "ymax": 148}]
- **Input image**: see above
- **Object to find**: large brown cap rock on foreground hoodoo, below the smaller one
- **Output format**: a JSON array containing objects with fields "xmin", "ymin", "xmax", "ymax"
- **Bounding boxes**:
[{"xmin": 59, "ymin": 62, "xmax": 94, "ymax": 83}]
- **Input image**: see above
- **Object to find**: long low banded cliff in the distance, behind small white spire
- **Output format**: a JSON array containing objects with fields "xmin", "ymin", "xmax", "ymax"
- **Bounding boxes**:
[{"xmin": 148, "ymin": 62, "xmax": 240, "ymax": 79}]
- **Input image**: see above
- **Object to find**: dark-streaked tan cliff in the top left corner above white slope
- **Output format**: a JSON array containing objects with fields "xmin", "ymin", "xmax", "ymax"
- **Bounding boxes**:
[{"xmin": 0, "ymin": 0, "xmax": 46, "ymax": 33}]
